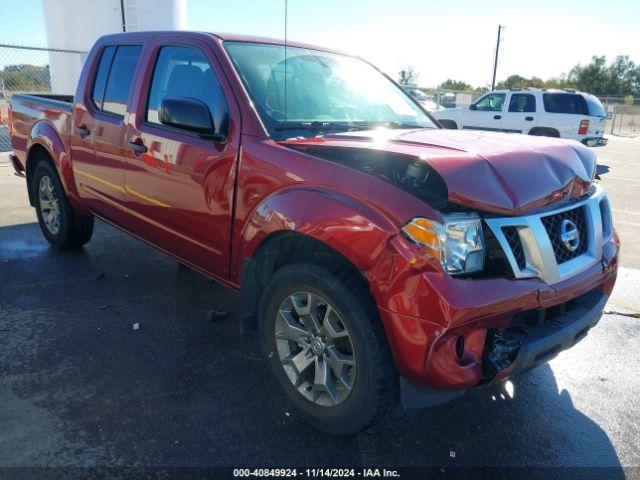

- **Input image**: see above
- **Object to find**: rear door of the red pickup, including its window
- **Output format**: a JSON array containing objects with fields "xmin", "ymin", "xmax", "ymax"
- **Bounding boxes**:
[{"xmin": 71, "ymin": 45, "xmax": 142, "ymax": 227}]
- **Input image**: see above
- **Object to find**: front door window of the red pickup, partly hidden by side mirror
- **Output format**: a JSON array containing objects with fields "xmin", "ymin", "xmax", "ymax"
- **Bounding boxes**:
[{"xmin": 146, "ymin": 46, "xmax": 228, "ymax": 132}]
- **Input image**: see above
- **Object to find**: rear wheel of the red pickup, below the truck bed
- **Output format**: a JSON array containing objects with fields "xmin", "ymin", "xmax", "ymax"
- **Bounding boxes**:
[{"xmin": 31, "ymin": 160, "xmax": 93, "ymax": 250}]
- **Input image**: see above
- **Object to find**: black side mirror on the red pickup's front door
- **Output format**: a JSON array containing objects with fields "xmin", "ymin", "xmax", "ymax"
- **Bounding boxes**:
[{"xmin": 159, "ymin": 97, "xmax": 226, "ymax": 142}]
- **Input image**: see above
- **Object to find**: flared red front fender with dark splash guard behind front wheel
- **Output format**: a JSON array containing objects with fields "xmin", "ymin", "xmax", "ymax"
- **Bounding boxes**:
[{"xmin": 236, "ymin": 186, "xmax": 398, "ymax": 335}]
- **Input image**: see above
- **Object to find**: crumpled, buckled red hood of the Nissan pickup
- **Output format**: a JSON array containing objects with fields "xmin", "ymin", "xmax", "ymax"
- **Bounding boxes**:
[{"xmin": 283, "ymin": 129, "xmax": 596, "ymax": 215}]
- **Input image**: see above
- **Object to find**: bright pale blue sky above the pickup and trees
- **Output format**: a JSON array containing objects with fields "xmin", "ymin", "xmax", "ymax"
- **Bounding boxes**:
[{"xmin": 0, "ymin": 0, "xmax": 640, "ymax": 86}]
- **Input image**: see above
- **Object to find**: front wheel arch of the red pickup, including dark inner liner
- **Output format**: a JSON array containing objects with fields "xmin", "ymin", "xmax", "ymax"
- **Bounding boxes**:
[{"xmin": 238, "ymin": 188, "xmax": 397, "ymax": 334}]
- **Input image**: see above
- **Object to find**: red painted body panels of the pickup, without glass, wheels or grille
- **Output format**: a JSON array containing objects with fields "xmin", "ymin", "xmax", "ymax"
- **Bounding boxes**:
[{"xmin": 7, "ymin": 32, "xmax": 619, "ymax": 389}]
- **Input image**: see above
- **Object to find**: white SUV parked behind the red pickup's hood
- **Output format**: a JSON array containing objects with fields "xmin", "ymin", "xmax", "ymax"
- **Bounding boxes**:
[{"xmin": 431, "ymin": 88, "xmax": 607, "ymax": 146}]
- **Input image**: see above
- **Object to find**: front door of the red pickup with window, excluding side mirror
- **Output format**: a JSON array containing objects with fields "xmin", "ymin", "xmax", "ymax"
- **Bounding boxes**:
[{"xmin": 126, "ymin": 37, "xmax": 240, "ymax": 277}]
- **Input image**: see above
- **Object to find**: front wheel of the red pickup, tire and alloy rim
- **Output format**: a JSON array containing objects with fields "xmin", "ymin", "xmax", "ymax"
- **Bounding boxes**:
[{"xmin": 260, "ymin": 263, "xmax": 397, "ymax": 435}]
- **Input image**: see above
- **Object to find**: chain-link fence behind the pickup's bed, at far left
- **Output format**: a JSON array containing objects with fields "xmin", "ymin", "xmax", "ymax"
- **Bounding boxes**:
[{"xmin": 0, "ymin": 44, "xmax": 87, "ymax": 151}]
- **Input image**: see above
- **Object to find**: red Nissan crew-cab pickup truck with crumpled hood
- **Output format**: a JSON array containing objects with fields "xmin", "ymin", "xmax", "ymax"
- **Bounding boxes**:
[{"xmin": 11, "ymin": 32, "xmax": 619, "ymax": 434}]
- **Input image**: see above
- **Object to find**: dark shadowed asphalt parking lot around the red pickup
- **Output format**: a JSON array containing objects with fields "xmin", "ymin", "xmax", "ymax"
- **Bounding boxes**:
[{"xmin": 0, "ymin": 138, "xmax": 640, "ymax": 479}]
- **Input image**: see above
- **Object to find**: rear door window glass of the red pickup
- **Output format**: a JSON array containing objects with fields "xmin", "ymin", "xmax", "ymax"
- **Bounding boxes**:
[{"xmin": 91, "ymin": 45, "xmax": 142, "ymax": 117}]
